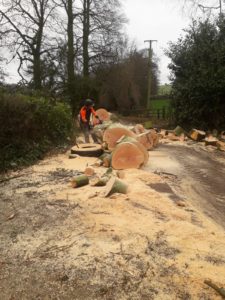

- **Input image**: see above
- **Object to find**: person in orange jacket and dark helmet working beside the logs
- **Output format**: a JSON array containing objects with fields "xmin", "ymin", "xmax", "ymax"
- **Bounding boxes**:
[{"xmin": 79, "ymin": 99, "xmax": 99, "ymax": 143}]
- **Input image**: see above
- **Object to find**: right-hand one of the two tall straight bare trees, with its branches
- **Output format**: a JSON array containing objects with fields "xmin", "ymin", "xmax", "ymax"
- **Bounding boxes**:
[{"xmin": 78, "ymin": 0, "xmax": 126, "ymax": 77}]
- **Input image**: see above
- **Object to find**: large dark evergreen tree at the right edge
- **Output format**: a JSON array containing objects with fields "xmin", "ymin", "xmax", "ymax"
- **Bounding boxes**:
[{"xmin": 167, "ymin": 15, "xmax": 225, "ymax": 128}]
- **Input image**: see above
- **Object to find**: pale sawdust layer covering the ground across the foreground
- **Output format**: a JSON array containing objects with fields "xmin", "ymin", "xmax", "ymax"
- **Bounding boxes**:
[{"xmin": 0, "ymin": 149, "xmax": 225, "ymax": 300}]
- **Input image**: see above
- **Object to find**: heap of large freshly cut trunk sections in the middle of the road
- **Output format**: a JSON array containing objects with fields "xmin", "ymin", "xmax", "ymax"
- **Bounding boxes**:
[{"xmin": 94, "ymin": 121, "xmax": 159, "ymax": 170}]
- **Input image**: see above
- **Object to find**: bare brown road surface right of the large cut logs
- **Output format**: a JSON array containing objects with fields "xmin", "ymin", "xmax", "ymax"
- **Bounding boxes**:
[{"xmin": 148, "ymin": 143, "xmax": 225, "ymax": 228}]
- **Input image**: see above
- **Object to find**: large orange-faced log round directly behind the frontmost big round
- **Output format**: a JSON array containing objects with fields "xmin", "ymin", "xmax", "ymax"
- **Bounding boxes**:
[{"xmin": 103, "ymin": 125, "xmax": 136, "ymax": 151}]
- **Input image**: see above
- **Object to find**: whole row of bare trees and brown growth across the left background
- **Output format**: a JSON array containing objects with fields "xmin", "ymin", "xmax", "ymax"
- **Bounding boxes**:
[{"xmin": 0, "ymin": 0, "xmax": 158, "ymax": 112}]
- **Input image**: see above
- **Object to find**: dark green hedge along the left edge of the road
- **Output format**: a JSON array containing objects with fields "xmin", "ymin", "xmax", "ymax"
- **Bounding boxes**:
[{"xmin": 0, "ymin": 93, "xmax": 72, "ymax": 171}]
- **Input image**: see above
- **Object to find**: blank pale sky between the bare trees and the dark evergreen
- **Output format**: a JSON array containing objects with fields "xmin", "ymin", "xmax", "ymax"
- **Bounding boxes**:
[{"xmin": 124, "ymin": 0, "xmax": 190, "ymax": 83}]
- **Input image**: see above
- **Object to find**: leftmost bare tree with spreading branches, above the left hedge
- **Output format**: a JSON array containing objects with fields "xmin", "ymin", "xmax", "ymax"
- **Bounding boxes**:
[{"xmin": 0, "ymin": 0, "xmax": 55, "ymax": 90}]
